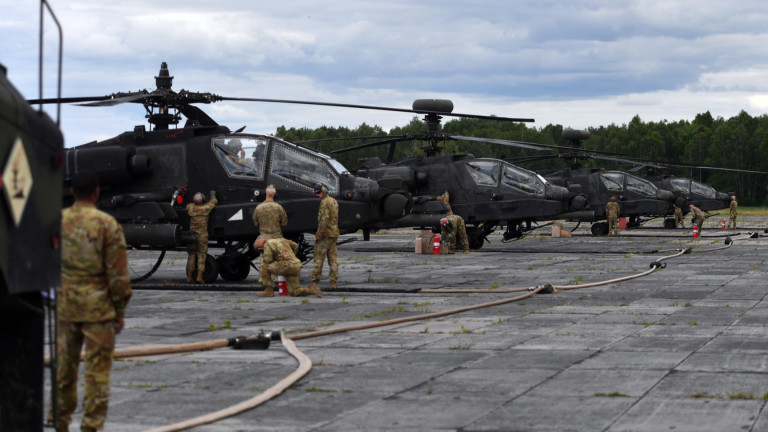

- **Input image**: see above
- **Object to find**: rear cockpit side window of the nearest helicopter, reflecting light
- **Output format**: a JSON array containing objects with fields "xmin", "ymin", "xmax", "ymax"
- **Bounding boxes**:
[{"xmin": 213, "ymin": 137, "xmax": 268, "ymax": 180}]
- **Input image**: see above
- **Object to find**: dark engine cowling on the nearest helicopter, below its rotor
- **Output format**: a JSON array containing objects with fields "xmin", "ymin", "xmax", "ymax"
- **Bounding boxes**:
[{"xmin": 64, "ymin": 146, "xmax": 152, "ymax": 186}]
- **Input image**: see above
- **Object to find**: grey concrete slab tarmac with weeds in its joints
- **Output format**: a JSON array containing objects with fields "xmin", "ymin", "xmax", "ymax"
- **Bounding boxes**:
[{"xmin": 48, "ymin": 218, "xmax": 768, "ymax": 432}]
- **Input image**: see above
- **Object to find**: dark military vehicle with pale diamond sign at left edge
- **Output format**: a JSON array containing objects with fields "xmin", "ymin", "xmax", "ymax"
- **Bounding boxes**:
[{"xmin": 0, "ymin": 0, "xmax": 64, "ymax": 431}]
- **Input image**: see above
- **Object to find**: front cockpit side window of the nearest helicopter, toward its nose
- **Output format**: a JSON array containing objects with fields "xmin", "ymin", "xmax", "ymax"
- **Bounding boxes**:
[{"xmin": 270, "ymin": 143, "xmax": 341, "ymax": 194}]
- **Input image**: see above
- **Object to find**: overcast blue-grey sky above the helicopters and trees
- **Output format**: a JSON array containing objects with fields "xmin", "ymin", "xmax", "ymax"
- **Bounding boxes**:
[{"xmin": 0, "ymin": 0, "xmax": 768, "ymax": 146}]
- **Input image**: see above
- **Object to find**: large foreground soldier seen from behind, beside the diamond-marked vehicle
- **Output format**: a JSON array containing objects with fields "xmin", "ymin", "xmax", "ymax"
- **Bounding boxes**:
[{"xmin": 51, "ymin": 173, "xmax": 131, "ymax": 432}]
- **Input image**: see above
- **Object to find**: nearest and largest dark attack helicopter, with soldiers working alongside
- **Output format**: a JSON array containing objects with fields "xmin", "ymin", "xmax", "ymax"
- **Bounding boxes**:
[{"xmin": 29, "ymin": 62, "xmax": 420, "ymax": 283}]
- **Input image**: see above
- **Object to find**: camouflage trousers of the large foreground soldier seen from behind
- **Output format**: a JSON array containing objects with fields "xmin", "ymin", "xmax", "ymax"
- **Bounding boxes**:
[{"xmin": 49, "ymin": 320, "xmax": 115, "ymax": 430}]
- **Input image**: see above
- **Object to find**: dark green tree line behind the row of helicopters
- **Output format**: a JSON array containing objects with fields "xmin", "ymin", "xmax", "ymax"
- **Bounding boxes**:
[{"xmin": 276, "ymin": 111, "xmax": 768, "ymax": 205}]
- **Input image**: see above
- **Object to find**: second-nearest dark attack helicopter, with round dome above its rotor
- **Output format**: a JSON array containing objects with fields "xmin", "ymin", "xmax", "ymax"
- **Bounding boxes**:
[{"xmin": 298, "ymin": 99, "xmax": 587, "ymax": 249}]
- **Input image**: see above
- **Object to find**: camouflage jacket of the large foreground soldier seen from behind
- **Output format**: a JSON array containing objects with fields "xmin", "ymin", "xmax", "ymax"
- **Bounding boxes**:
[{"xmin": 56, "ymin": 202, "xmax": 131, "ymax": 322}]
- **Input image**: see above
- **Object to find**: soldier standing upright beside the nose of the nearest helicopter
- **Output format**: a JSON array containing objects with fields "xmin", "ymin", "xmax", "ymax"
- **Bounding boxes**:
[{"xmin": 308, "ymin": 183, "xmax": 339, "ymax": 291}]
